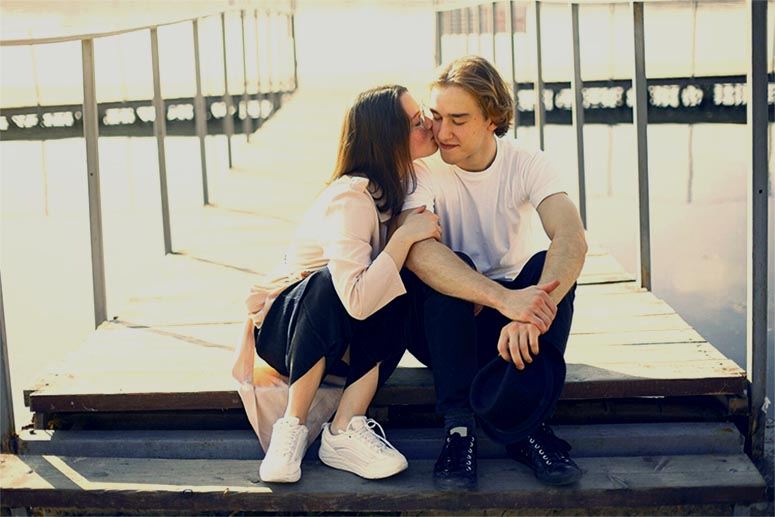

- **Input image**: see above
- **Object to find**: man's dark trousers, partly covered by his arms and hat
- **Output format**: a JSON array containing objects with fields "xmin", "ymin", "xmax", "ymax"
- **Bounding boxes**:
[{"xmin": 405, "ymin": 251, "xmax": 576, "ymax": 424}]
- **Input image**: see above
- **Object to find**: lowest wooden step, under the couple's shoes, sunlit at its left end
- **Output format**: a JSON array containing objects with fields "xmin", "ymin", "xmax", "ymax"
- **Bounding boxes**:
[{"xmin": 0, "ymin": 454, "xmax": 765, "ymax": 512}]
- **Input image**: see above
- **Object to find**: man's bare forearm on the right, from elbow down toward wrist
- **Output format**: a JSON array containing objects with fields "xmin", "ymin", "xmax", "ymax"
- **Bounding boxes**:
[{"xmin": 538, "ymin": 229, "xmax": 587, "ymax": 304}]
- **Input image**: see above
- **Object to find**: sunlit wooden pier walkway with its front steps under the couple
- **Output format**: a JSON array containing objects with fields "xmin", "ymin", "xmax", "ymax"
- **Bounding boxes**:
[{"xmin": 0, "ymin": 90, "xmax": 765, "ymax": 513}]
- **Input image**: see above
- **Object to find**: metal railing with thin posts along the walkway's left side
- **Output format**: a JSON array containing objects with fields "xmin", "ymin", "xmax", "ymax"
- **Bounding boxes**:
[{"xmin": 0, "ymin": 0, "xmax": 298, "ymax": 452}]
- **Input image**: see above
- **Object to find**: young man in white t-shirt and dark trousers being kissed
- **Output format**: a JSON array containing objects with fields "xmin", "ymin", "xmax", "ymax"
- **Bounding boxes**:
[{"xmin": 404, "ymin": 56, "xmax": 587, "ymax": 488}]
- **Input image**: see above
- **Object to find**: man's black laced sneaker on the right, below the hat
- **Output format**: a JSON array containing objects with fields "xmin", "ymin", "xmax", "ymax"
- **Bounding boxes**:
[{"xmin": 506, "ymin": 424, "xmax": 582, "ymax": 486}]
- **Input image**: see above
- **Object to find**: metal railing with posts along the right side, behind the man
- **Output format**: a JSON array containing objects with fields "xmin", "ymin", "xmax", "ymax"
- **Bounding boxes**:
[{"xmin": 435, "ymin": 0, "xmax": 770, "ymax": 457}]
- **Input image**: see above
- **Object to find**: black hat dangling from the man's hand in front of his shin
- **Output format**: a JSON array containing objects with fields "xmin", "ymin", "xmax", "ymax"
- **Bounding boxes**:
[{"xmin": 471, "ymin": 343, "xmax": 566, "ymax": 444}]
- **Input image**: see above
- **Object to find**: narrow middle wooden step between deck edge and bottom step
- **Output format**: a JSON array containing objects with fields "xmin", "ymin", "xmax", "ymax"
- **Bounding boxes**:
[{"xmin": 19, "ymin": 422, "xmax": 743, "ymax": 460}]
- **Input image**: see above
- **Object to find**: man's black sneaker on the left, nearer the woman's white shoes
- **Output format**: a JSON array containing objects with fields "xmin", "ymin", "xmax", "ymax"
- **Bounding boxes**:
[{"xmin": 433, "ymin": 429, "xmax": 477, "ymax": 490}]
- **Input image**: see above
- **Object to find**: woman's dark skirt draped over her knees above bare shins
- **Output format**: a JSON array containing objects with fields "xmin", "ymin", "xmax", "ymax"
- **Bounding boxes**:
[{"xmin": 255, "ymin": 267, "xmax": 409, "ymax": 386}]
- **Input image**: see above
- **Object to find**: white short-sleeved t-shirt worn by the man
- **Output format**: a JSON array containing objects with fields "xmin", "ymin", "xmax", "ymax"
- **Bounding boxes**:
[{"xmin": 404, "ymin": 137, "xmax": 568, "ymax": 280}]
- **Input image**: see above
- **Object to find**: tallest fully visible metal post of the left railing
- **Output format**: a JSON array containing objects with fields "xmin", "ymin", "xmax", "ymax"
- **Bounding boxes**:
[{"xmin": 81, "ymin": 39, "xmax": 108, "ymax": 328}]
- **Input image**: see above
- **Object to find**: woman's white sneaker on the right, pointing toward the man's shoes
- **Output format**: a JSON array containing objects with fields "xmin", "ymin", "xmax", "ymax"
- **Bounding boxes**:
[{"xmin": 318, "ymin": 416, "xmax": 409, "ymax": 479}]
